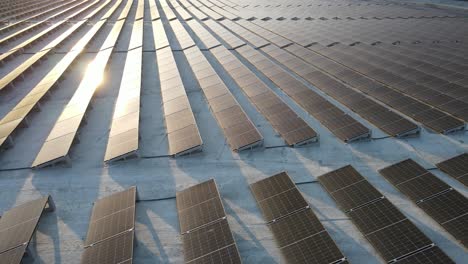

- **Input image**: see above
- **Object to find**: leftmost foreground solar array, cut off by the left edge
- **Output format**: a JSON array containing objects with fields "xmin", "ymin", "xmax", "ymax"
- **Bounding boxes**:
[{"xmin": 0, "ymin": 196, "xmax": 55, "ymax": 264}]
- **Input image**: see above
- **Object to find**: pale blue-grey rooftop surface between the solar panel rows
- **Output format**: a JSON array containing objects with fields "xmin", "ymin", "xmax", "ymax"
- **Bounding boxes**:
[{"xmin": 0, "ymin": 0, "xmax": 468, "ymax": 264}]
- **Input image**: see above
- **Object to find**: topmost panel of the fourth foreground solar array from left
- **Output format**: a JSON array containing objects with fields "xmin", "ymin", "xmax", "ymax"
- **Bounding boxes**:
[{"xmin": 250, "ymin": 172, "xmax": 296, "ymax": 202}]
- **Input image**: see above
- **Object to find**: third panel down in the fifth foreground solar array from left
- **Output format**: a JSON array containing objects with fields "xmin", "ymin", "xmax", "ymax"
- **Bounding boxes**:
[{"xmin": 366, "ymin": 219, "xmax": 432, "ymax": 262}]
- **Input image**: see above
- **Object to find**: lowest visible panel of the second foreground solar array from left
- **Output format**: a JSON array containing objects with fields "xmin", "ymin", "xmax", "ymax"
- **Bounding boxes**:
[{"xmin": 81, "ymin": 231, "xmax": 134, "ymax": 264}]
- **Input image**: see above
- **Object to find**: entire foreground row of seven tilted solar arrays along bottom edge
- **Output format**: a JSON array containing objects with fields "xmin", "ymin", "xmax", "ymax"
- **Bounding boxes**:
[{"xmin": 0, "ymin": 154, "xmax": 468, "ymax": 264}]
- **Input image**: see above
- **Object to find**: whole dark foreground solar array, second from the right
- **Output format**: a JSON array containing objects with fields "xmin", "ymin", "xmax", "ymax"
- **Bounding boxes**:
[{"xmin": 379, "ymin": 159, "xmax": 468, "ymax": 250}]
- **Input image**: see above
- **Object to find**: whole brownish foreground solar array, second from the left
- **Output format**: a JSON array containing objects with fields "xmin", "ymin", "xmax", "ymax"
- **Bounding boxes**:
[{"xmin": 81, "ymin": 187, "xmax": 137, "ymax": 264}]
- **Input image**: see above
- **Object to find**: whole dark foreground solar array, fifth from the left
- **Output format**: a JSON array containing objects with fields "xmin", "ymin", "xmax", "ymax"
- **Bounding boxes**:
[{"xmin": 318, "ymin": 165, "xmax": 454, "ymax": 263}]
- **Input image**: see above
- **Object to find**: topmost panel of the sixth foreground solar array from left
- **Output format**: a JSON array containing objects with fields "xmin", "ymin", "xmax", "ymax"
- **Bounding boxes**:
[{"xmin": 379, "ymin": 159, "xmax": 427, "ymax": 185}]
